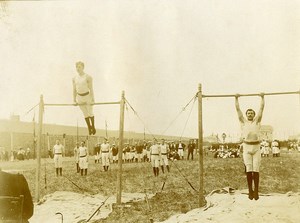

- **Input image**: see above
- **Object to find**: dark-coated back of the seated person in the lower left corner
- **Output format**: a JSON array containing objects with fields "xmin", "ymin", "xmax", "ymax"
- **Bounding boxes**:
[{"xmin": 0, "ymin": 168, "xmax": 34, "ymax": 223}]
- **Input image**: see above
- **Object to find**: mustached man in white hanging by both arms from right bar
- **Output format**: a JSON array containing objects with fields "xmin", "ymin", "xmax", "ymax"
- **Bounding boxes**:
[{"xmin": 235, "ymin": 93, "xmax": 265, "ymax": 200}]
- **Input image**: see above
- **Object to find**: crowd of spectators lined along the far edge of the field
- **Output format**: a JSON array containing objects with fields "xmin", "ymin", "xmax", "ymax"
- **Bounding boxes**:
[{"xmin": 0, "ymin": 139, "xmax": 300, "ymax": 163}]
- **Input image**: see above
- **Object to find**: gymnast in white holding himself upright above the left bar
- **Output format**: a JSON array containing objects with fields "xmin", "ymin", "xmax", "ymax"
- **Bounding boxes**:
[{"xmin": 73, "ymin": 61, "xmax": 96, "ymax": 135}]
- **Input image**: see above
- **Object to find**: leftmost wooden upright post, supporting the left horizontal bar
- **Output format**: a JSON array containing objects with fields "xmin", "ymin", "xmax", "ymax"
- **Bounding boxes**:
[{"xmin": 35, "ymin": 95, "xmax": 44, "ymax": 202}]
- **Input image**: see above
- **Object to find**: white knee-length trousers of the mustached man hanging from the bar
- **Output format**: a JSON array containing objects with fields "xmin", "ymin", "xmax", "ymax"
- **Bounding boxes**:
[{"xmin": 243, "ymin": 143, "xmax": 261, "ymax": 172}]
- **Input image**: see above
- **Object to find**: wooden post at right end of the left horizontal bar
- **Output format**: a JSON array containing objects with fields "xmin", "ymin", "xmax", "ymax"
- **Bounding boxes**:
[{"xmin": 117, "ymin": 91, "xmax": 125, "ymax": 205}]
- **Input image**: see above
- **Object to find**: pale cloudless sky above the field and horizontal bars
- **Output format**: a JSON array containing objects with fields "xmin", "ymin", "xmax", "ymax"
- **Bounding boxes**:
[{"xmin": 0, "ymin": 0, "xmax": 300, "ymax": 138}]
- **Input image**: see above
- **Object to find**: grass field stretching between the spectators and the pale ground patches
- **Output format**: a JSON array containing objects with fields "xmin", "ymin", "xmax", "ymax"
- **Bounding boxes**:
[{"xmin": 1, "ymin": 152, "xmax": 300, "ymax": 222}]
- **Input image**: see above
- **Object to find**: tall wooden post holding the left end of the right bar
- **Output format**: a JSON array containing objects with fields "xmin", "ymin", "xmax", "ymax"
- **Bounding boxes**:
[{"xmin": 198, "ymin": 84, "xmax": 205, "ymax": 207}]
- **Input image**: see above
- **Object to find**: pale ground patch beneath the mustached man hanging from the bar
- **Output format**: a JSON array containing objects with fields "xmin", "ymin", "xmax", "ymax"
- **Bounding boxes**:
[{"xmin": 159, "ymin": 189, "xmax": 300, "ymax": 223}]
